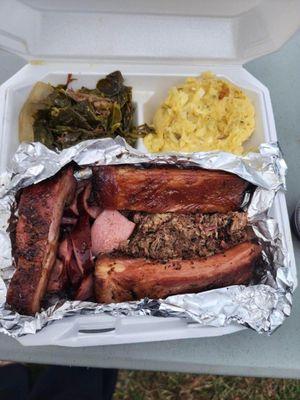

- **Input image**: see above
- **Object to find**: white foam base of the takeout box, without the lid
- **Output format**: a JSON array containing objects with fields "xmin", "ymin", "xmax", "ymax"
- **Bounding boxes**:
[{"xmin": 0, "ymin": 63, "xmax": 296, "ymax": 346}]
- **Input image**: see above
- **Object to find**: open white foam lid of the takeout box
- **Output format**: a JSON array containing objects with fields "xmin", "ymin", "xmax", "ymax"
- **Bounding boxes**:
[{"xmin": 0, "ymin": 0, "xmax": 300, "ymax": 64}]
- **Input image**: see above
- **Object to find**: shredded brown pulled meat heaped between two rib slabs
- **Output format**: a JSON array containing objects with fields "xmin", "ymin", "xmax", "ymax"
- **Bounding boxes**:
[{"xmin": 118, "ymin": 211, "xmax": 252, "ymax": 260}]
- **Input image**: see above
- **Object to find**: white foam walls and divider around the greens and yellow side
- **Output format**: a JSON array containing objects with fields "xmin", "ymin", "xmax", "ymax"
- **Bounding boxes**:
[{"xmin": 0, "ymin": 63, "xmax": 276, "ymax": 170}]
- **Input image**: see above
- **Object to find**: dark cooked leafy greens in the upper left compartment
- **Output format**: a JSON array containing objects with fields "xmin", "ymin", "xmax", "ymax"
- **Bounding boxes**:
[{"xmin": 20, "ymin": 71, "xmax": 147, "ymax": 150}]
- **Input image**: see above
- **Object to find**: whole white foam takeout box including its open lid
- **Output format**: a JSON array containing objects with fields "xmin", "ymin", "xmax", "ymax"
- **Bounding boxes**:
[{"xmin": 0, "ymin": 0, "xmax": 300, "ymax": 346}]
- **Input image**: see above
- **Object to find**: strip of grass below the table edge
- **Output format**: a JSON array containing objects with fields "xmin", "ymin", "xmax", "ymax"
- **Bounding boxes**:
[{"xmin": 114, "ymin": 371, "xmax": 300, "ymax": 400}]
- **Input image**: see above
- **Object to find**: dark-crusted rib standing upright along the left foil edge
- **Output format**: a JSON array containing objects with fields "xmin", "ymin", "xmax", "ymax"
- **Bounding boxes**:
[{"xmin": 7, "ymin": 168, "xmax": 76, "ymax": 314}]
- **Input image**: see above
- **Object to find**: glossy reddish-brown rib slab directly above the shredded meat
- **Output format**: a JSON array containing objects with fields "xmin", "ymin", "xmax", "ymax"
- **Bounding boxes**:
[{"xmin": 93, "ymin": 166, "xmax": 248, "ymax": 213}]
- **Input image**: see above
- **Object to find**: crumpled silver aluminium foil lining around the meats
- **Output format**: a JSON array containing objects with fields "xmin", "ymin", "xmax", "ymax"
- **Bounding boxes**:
[{"xmin": 0, "ymin": 137, "xmax": 297, "ymax": 337}]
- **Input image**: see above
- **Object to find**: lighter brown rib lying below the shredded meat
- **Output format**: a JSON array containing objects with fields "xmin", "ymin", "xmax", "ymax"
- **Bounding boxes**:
[{"xmin": 95, "ymin": 242, "xmax": 261, "ymax": 303}]
